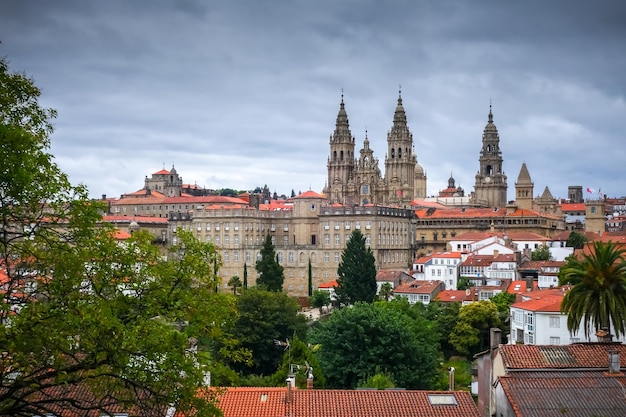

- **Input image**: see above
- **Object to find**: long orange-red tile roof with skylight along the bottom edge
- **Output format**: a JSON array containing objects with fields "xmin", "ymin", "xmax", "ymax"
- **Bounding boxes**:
[{"xmin": 188, "ymin": 387, "xmax": 479, "ymax": 417}]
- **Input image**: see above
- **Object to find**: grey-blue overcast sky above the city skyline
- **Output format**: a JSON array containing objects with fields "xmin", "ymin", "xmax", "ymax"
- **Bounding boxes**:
[{"xmin": 0, "ymin": 0, "xmax": 626, "ymax": 199}]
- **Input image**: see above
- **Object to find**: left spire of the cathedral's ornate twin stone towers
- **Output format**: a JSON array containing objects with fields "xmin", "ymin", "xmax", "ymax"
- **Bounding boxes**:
[{"xmin": 325, "ymin": 91, "xmax": 355, "ymax": 203}]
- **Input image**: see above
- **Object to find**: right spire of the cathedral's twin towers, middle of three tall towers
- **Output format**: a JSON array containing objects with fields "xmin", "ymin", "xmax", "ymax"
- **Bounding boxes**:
[{"xmin": 385, "ymin": 92, "xmax": 417, "ymax": 205}]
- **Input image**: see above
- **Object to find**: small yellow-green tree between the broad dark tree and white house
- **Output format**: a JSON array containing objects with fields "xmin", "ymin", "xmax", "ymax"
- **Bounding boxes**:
[{"xmin": 450, "ymin": 300, "xmax": 501, "ymax": 356}]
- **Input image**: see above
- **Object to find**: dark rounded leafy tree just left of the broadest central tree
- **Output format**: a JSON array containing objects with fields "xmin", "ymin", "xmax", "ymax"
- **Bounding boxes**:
[{"xmin": 232, "ymin": 288, "xmax": 307, "ymax": 376}]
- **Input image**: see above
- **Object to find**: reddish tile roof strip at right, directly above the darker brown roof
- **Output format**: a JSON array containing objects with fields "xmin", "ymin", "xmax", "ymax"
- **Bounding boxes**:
[{"xmin": 498, "ymin": 343, "xmax": 626, "ymax": 371}]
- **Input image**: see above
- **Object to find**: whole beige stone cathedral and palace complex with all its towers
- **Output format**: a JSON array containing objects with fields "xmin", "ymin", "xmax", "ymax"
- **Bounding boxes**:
[{"xmin": 103, "ymin": 96, "xmax": 576, "ymax": 296}]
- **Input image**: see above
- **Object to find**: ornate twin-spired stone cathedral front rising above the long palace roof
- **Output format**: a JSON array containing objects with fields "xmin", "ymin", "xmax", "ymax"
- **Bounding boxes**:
[{"xmin": 323, "ymin": 94, "xmax": 426, "ymax": 206}]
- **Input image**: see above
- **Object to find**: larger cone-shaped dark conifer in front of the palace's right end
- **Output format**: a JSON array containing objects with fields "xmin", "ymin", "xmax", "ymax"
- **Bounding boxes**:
[{"xmin": 335, "ymin": 229, "xmax": 377, "ymax": 305}]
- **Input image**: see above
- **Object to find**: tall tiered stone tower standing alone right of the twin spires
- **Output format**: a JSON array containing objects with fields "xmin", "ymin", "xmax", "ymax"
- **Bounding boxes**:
[{"xmin": 474, "ymin": 105, "xmax": 507, "ymax": 207}]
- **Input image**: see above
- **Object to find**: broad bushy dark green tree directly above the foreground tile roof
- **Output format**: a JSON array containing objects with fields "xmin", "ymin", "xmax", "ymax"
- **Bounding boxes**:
[{"xmin": 309, "ymin": 301, "xmax": 439, "ymax": 389}]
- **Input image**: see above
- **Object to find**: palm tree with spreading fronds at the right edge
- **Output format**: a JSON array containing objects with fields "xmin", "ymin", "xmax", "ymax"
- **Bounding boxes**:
[{"xmin": 559, "ymin": 242, "xmax": 626, "ymax": 337}]
